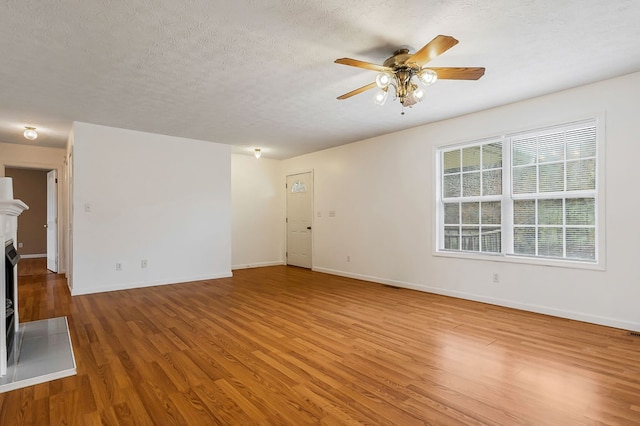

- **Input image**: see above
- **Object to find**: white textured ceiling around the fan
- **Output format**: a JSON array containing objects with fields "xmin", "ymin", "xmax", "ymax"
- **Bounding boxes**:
[{"xmin": 0, "ymin": 0, "xmax": 640, "ymax": 158}]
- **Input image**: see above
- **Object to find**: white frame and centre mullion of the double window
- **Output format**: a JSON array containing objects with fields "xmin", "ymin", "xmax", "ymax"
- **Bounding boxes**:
[{"xmin": 433, "ymin": 114, "xmax": 606, "ymax": 270}]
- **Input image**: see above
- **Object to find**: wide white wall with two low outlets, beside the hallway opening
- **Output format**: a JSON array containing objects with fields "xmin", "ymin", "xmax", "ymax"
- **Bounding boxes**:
[{"xmin": 72, "ymin": 123, "xmax": 231, "ymax": 295}]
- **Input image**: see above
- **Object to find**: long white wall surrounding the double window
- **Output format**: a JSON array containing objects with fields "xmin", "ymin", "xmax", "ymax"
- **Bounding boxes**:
[{"xmin": 282, "ymin": 73, "xmax": 640, "ymax": 330}]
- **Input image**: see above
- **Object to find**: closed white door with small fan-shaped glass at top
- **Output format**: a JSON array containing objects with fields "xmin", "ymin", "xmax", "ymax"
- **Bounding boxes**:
[{"xmin": 287, "ymin": 172, "xmax": 313, "ymax": 268}]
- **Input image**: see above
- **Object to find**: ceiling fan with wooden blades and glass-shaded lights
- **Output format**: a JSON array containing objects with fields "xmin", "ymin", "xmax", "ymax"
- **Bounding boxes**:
[{"xmin": 335, "ymin": 35, "xmax": 484, "ymax": 109}]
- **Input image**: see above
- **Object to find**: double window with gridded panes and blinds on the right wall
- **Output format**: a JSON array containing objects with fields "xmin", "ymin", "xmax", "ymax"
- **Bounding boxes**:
[{"xmin": 437, "ymin": 120, "xmax": 598, "ymax": 262}]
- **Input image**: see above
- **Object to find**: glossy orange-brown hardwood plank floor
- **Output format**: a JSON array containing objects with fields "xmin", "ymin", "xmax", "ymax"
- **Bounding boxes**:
[{"xmin": 0, "ymin": 261, "xmax": 640, "ymax": 425}]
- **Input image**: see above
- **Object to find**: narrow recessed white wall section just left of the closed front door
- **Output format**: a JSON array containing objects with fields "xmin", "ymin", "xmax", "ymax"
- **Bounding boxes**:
[{"xmin": 231, "ymin": 154, "xmax": 285, "ymax": 269}]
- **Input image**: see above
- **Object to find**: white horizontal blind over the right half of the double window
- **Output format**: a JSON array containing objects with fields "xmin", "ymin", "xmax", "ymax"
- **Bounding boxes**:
[{"xmin": 511, "ymin": 123, "xmax": 597, "ymax": 260}]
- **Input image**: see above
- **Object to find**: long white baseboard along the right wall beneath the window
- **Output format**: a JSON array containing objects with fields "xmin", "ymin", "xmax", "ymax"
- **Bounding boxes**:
[{"xmin": 313, "ymin": 267, "xmax": 640, "ymax": 331}]
